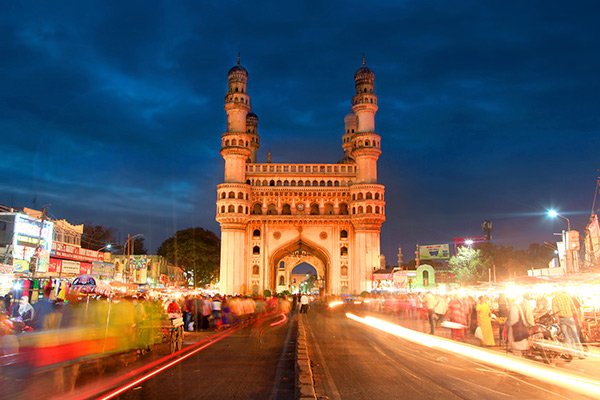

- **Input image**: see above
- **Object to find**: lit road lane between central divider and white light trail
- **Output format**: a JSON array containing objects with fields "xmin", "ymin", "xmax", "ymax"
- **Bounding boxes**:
[{"xmin": 301, "ymin": 307, "xmax": 587, "ymax": 400}]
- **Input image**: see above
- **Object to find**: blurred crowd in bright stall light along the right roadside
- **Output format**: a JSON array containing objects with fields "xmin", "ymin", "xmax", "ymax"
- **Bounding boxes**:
[{"xmin": 356, "ymin": 291, "xmax": 584, "ymax": 355}]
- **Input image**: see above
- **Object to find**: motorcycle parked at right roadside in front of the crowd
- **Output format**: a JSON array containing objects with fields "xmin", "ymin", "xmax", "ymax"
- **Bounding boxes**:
[{"xmin": 526, "ymin": 312, "xmax": 573, "ymax": 364}]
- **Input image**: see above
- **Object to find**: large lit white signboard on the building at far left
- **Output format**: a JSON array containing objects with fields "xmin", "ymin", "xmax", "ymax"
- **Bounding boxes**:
[{"xmin": 12, "ymin": 214, "xmax": 54, "ymax": 273}]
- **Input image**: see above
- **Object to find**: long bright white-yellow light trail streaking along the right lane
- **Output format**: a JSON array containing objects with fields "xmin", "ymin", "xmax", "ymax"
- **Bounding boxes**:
[{"xmin": 346, "ymin": 313, "xmax": 600, "ymax": 398}]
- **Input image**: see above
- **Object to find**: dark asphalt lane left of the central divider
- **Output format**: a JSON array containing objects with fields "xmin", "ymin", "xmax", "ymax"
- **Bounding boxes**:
[{"xmin": 111, "ymin": 320, "xmax": 295, "ymax": 400}]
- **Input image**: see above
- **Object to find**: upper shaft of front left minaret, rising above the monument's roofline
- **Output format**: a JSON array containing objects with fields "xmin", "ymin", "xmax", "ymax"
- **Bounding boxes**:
[{"xmin": 221, "ymin": 55, "xmax": 252, "ymax": 183}]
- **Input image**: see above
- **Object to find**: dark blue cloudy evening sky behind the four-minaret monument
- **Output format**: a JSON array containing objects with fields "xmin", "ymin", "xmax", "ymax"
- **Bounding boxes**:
[{"xmin": 0, "ymin": 1, "xmax": 600, "ymax": 264}]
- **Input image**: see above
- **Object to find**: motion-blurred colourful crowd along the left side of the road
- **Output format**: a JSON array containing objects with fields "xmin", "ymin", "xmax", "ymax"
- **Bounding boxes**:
[{"xmin": 0, "ymin": 286, "xmax": 309, "ymax": 392}]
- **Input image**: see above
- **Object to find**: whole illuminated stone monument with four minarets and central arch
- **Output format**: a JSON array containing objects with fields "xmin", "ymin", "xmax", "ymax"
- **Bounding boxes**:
[{"xmin": 217, "ymin": 58, "xmax": 385, "ymax": 294}]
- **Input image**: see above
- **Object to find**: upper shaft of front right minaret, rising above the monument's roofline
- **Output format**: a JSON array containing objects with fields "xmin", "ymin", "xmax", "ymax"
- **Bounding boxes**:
[{"xmin": 351, "ymin": 56, "xmax": 381, "ymax": 183}]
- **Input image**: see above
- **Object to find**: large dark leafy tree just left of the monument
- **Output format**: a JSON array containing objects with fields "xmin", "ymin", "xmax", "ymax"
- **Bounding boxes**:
[{"xmin": 158, "ymin": 228, "xmax": 221, "ymax": 287}]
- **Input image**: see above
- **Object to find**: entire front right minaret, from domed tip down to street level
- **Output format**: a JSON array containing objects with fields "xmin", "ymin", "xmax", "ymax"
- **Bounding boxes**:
[{"xmin": 344, "ymin": 56, "xmax": 385, "ymax": 293}]
